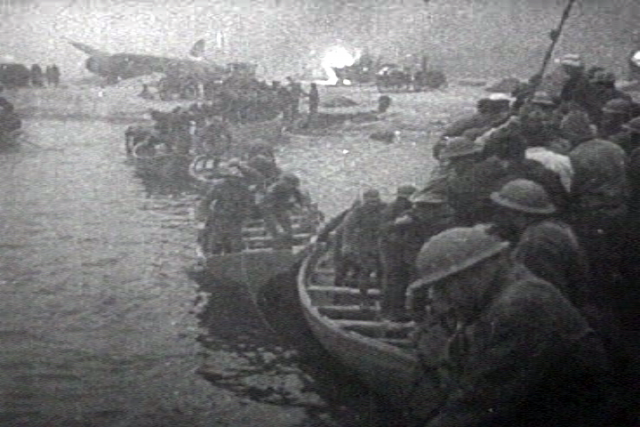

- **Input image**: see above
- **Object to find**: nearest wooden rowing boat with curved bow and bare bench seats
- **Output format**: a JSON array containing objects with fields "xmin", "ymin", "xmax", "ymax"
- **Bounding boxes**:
[{"xmin": 297, "ymin": 241, "xmax": 417, "ymax": 408}]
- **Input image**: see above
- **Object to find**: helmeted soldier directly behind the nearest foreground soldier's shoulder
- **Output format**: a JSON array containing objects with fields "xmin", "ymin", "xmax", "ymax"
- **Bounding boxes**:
[{"xmin": 491, "ymin": 179, "xmax": 633, "ymax": 412}]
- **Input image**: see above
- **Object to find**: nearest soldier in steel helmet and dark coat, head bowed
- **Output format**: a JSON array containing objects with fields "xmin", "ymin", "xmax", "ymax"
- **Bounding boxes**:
[{"xmin": 407, "ymin": 226, "xmax": 612, "ymax": 427}]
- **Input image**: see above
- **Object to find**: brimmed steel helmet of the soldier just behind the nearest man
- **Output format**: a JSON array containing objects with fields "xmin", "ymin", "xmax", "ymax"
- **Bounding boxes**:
[{"xmin": 491, "ymin": 179, "xmax": 557, "ymax": 215}]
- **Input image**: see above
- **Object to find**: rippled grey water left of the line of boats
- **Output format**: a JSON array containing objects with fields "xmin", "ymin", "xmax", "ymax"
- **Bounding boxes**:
[{"xmin": 0, "ymin": 120, "xmax": 380, "ymax": 427}]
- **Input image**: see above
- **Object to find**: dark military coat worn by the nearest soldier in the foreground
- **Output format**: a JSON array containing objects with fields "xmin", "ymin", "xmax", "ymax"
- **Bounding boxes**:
[{"xmin": 418, "ymin": 267, "xmax": 612, "ymax": 427}]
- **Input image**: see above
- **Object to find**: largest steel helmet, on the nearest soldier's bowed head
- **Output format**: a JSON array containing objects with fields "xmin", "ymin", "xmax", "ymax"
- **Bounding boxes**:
[{"xmin": 411, "ymin": 225, "xmax": 509, "ymax": 289}]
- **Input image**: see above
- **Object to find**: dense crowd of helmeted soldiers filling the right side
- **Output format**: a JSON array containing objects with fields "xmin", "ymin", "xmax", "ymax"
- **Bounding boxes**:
[{"xmin": 319, "ymin": 55, "xmax": 640, "ymax": 427}]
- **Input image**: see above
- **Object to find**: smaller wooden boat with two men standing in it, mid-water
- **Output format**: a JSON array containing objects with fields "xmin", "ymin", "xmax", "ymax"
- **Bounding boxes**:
[{"xmin": 204, "ymin": 210, "xmax": 321, "ymax": 301}]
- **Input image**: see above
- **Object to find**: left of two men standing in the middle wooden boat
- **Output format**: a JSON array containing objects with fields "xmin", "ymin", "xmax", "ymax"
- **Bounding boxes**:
[{"xmin": 198, "ymin": 163, "xmax": 253, "ymax": 255}]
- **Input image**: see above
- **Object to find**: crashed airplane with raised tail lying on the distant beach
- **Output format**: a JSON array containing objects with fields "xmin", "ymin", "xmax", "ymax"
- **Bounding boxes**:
[{"xmin": 69, "ymin": 39, "xmax": 227, "ymax": 84}]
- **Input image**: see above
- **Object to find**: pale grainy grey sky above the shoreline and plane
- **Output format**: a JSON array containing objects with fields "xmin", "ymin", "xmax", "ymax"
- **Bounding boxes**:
[{"xmin": 0, "ymin": 0, "xmax": 640, "ymax": 77}]
